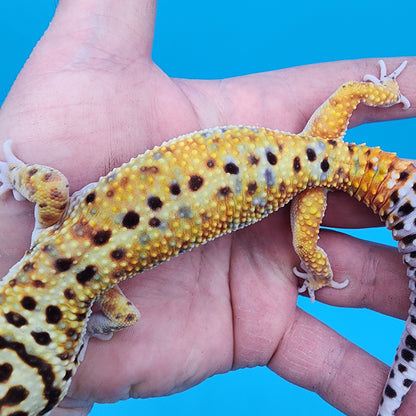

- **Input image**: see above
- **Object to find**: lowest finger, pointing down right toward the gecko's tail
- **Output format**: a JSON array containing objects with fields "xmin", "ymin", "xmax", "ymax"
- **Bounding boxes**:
[{"xmin": 268, "ymin": 309, "xmax": 388, "ymax": 416}]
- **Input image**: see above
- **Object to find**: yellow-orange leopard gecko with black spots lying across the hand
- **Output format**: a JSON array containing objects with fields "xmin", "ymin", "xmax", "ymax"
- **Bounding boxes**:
[{"xmin": 0, "ymin": 60, "xmax": 416, "ymax": 416}]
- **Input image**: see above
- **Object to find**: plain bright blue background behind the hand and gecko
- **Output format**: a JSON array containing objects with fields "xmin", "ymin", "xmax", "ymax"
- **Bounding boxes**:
[{"xmin": 0, "ymin": 0, "xmax": 416, "ymax": 416}]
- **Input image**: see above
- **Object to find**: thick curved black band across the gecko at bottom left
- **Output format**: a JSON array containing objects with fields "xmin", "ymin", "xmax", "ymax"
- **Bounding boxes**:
[{"xmin": 0, "ymin": 336, "xmax": 61, "ymax": 415}]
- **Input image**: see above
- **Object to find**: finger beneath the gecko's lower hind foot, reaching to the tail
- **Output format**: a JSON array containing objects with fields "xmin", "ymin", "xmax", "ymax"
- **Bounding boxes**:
[{"xmin": 308, "ymin": 230, "xmax": 409, "ymax": 319}]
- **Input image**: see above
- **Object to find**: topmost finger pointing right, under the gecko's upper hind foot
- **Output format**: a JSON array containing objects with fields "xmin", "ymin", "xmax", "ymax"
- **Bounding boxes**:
[{"xmin": 183, "ymin": 57, "xmax": 416, "ymax": 133}]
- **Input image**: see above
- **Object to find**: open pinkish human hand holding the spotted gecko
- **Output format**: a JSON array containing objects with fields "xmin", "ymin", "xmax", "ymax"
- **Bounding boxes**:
[{"xmin": 0, "ymin": 0, "xmax": 416, "ymax": 416}]
